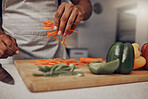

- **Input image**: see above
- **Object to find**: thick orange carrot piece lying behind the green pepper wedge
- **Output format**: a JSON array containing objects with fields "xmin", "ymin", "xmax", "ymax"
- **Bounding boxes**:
[{"xmin": 80, "ymin": 57, "xmax": 103, "ymax": 63}]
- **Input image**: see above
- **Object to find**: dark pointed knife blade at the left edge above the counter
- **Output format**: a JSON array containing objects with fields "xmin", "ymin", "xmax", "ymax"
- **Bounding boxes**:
[{"xmin": 0, "ymin": 64, "xmax": 14, "ymax": 85}]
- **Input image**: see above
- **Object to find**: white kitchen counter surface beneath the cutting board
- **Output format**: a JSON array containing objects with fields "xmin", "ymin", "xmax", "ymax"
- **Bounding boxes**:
[{"xmin": 0, "ymin": 60, "xmax": 148, "ymax": 99}]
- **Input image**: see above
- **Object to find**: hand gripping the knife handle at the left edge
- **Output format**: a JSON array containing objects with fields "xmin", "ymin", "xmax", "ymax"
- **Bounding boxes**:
[{"xmin": 0, "ymin": 32, "xmax": 20, "ymax": 59}]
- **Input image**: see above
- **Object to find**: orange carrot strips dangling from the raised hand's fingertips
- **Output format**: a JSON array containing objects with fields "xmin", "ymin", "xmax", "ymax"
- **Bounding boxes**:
[{"xmin": 42, "ymin": 20, "xmax": 78, "ymax": 47}]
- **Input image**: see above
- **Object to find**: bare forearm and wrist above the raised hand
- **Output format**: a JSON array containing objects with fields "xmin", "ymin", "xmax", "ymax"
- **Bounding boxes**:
[{"xmin": 71, "ymin": 0, "xmax": 92, "ymax": 20}]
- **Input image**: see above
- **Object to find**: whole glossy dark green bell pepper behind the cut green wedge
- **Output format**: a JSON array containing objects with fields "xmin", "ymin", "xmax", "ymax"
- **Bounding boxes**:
[{"xmin": 106, "ymin": 42, "xmax": 134, "ymax": 74}]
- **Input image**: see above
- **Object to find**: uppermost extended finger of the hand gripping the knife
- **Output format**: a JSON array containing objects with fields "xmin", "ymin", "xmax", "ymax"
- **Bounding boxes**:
[{"xmin": 3, "ymin": 39, "xmax": 19, "ymax": 54}]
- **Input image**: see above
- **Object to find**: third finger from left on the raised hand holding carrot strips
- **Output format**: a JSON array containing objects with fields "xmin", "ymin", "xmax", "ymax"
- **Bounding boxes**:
[{"xmin": 63, "ymin": 8, "xmax": 78, "ymax": 36}]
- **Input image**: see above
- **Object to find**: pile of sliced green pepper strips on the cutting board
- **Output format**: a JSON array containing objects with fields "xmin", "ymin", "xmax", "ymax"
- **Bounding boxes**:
[{"xmin": 33, "ymin": 63, "xmax": 84, "ymax": 77}]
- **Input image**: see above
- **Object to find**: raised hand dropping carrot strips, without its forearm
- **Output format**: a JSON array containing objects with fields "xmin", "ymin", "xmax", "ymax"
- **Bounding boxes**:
[{"xmin": 54, "ymin": 2, "xmax": 84, "ymax": 36}]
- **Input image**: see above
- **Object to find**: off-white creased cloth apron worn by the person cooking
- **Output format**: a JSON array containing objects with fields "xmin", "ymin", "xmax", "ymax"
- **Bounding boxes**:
[{"xmin": 2, "ymin": 0, "xmax": 67, "ymax": 59}]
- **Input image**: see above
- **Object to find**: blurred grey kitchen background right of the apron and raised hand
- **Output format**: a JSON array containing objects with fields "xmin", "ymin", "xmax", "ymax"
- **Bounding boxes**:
[{"xmin": 0, "ymin": 0, "xmax": 148, "ymax": 58}]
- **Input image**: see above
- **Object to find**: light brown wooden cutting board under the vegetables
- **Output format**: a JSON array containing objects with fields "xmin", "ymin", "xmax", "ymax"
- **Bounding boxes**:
[{"xmin": 14, "ymin": 60, "xmax": 148, "ymax": 92}]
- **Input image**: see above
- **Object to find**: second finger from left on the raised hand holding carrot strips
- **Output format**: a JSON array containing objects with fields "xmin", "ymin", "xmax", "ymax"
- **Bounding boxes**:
[{"xmin": 58, "ymin": 4, "xmax": 74, "ymax": 35}]
